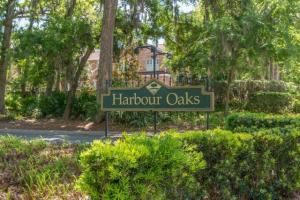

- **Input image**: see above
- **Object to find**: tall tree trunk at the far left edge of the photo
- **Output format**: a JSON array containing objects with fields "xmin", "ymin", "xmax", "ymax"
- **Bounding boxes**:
[{"xmin": 0, "ymin": 0, "xmax": 16, "ymax": 114}]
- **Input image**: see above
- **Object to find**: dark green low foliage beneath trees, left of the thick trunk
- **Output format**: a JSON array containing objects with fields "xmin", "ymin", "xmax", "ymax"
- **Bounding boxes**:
[{"xmin": 6, "ymin": 91, "xmax": 98, "ymax": 120}]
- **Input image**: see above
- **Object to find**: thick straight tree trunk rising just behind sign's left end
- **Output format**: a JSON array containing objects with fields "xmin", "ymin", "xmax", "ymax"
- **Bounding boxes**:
[{"xmin": 96, "ymin": 0, "xmax": 118, "ymax": 122}]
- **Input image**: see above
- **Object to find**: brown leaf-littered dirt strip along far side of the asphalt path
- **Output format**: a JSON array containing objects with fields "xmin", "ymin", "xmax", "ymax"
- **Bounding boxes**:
[{"xmin": 0, "ymin": 118, "xmax": 203, "ymax": 132}]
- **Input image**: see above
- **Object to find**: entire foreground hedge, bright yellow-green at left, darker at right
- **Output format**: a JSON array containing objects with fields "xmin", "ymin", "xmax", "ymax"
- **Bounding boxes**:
[{"xmin": 77, "ymin": 129, "xmax": 300, "ymax": 200}]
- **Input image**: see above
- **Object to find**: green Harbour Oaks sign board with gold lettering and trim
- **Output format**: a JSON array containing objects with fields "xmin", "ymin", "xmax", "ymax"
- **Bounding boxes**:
[{"xmin": 101, "ymin": 79, "xmax": 214, "ymax": 111}]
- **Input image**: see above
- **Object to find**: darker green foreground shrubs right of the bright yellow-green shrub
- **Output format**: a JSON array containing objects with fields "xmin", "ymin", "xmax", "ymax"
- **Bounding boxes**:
[{"xmin": 179, "ymin": 129, "xmax": 300, "ymax": 200}]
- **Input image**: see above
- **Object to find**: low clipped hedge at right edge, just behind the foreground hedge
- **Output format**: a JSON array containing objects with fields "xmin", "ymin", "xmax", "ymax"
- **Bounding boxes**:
[{"xmin": 226, "ymin": 113, "xmax": 300, "ymax": 132}]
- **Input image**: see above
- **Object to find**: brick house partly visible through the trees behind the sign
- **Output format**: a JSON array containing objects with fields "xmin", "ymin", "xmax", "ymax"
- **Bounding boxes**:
[{"xmin": 88, "ymin": 45, "xmax": 172, "ymax": 88}]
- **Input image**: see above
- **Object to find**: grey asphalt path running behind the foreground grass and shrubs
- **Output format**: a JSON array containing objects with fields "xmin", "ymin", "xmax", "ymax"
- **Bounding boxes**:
[{"xmin": 0, "ymin": 129, "xmax": 122, "ymax": 143}]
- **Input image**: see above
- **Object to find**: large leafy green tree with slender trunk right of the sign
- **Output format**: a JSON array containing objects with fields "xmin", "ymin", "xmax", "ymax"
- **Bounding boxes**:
[{"xmin": 165, "ymin": 0, "xmax": 299, "ymax": 113}]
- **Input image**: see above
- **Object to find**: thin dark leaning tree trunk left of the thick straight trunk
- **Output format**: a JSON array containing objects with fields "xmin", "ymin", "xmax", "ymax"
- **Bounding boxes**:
[{"xmin": 64, "ymin": 46, "xmax": 94, "ymax": 120}]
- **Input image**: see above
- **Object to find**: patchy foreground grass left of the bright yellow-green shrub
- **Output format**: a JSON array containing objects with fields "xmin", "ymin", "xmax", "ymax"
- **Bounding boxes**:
[{"xmin": 0, "ymin": 136, "xmax": 86, "ymax": 199}]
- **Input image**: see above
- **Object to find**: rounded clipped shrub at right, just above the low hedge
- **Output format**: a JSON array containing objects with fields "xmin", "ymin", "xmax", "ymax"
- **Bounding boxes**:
[{"xmin": 246, "ymin": 92, "xmax": 293, "ymax": 113}]
